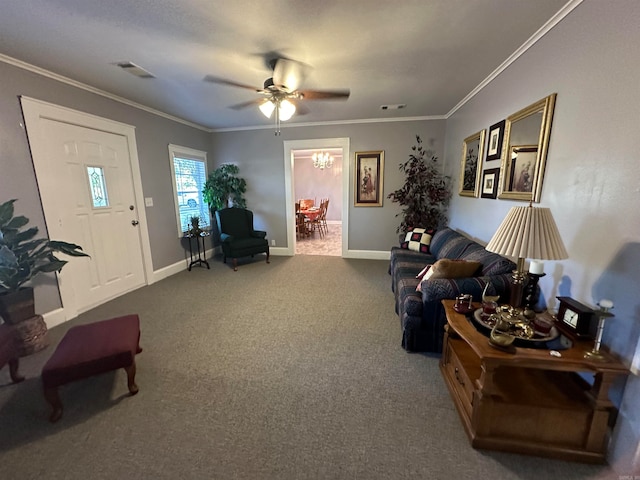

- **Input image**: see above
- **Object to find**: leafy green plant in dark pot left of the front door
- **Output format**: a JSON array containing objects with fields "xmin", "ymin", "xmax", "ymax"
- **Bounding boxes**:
[{"xmin": 0, "ymin": 199, "xmax": 89, "ymax": 324}]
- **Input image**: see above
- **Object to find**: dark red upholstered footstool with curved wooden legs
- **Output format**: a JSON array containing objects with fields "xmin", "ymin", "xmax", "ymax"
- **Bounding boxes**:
[{"xmin": 42, "ymin": 315, "xmax": 142, "ymax": 422}]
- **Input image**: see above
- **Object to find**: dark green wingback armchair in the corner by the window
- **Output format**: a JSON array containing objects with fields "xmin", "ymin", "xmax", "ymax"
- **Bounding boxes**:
[{"xmin": 216, "ymin": 207, "xmax": 269, "ymax": 271}]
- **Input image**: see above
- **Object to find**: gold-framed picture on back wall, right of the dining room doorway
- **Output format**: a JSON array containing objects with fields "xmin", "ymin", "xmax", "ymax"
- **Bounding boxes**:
[{"xmin": 353, "ymin": 150, "xmax": 384, "ymax": 207}]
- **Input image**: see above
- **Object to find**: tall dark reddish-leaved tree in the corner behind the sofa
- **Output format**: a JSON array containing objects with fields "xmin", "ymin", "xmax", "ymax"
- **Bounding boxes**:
[{"xmin": 387, "ymin": 135, "xmax": 451, "ymax": 233}]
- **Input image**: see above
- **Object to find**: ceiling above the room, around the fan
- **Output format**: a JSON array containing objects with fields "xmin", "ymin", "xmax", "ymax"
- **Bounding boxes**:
[{"xmin": 0, "ymin": 0, "xmax": 576, "ymax": 129}]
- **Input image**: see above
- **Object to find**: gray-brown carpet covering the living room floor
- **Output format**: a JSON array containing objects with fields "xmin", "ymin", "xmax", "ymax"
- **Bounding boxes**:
[{"xmin": 0, "ymin": 255, "xmax": 617, "ymax": 480}]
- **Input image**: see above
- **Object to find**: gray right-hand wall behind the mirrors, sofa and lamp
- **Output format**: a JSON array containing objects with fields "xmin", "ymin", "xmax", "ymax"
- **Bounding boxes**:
[{"xmin": 445, "ymin": 0, "xmax": 640, "ymax": 474}]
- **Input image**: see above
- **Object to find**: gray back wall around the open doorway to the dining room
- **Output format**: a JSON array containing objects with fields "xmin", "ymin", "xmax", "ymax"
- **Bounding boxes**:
[{"xmin": 210, "ymin": 120, "xmax": 445, "ymax": 252}]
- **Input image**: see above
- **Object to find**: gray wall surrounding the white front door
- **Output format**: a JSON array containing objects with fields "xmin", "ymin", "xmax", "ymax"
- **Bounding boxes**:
[{"xmin": 0, "ymin": 62, "xmax": 211, "ymax": 313}]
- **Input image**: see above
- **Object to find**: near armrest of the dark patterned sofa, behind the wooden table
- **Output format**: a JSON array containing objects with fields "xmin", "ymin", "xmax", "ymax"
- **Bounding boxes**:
[{"xmin": 421, "ymin": 273, "xmax": 511, "ymax": 303}]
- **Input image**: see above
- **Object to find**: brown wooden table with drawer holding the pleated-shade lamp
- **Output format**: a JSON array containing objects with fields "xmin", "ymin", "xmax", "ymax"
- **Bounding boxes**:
[{"xmin": 440, "ymin": 300, "xmax": 629, "ymax": 463}]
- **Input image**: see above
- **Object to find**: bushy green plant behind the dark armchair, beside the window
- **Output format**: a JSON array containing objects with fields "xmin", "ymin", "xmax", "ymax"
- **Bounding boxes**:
[{"xmin": 202, "ymin": 163, "xmax": 247, "ymax": 212}]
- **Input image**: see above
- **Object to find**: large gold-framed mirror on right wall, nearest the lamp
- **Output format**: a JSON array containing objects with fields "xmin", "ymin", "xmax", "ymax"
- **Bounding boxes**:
[{"xmin": 498, "ymin": 93, "xmax": 556, "ymax": 202}]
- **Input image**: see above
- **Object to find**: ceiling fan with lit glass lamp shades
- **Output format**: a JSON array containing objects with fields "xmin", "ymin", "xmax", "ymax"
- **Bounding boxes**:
[{"xmin": 204, "ymin": 57, "xmax": 350, "ymax": 135}]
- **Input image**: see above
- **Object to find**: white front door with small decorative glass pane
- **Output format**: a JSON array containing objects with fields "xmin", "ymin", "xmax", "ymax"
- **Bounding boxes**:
[{"xmin": 23, "ymin": 99, "xmax": 147, "ymax": 318}]
